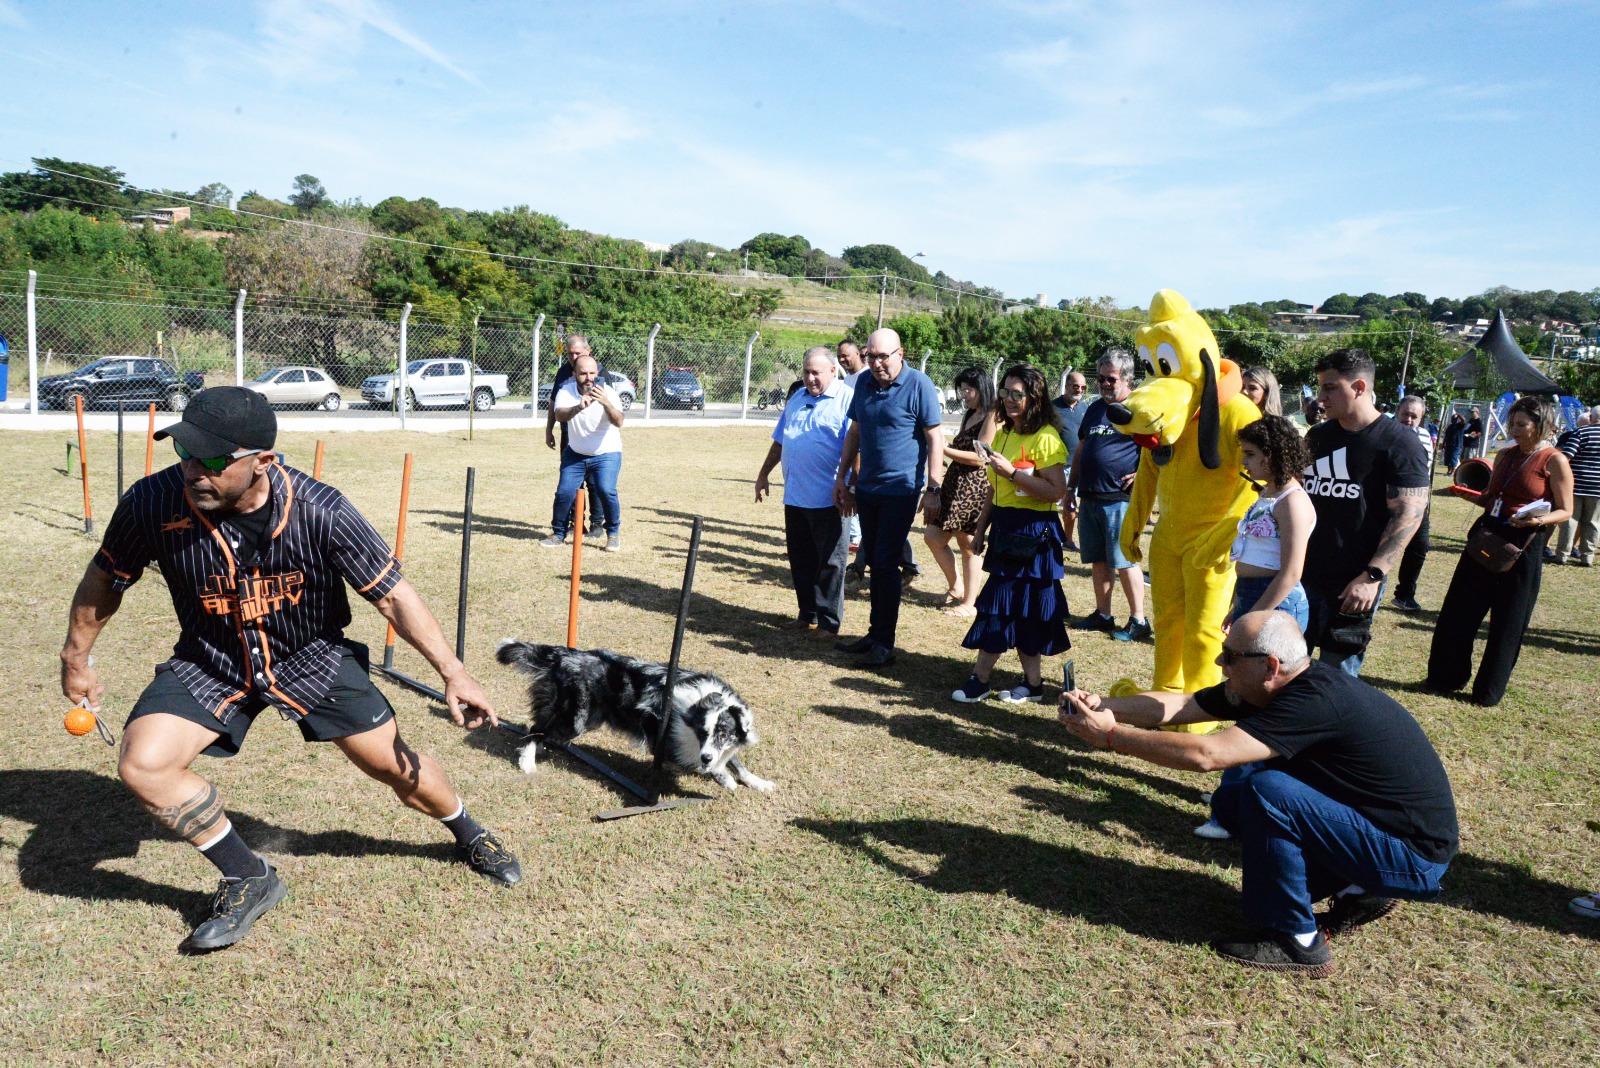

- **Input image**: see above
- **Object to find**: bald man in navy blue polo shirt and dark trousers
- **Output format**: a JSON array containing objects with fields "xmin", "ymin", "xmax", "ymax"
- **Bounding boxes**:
[{"xmin": 834, "ymin": 329, "xmax": 944, "ymax": 667}]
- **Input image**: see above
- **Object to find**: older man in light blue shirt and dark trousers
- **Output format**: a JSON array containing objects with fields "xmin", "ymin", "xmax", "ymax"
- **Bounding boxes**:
[{"xmin": 755, "ymin": 345, "xmax": 854, "ymax": 636}]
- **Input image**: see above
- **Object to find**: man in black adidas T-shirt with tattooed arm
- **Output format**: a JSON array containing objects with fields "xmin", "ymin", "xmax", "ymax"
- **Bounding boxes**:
[{"xmin": 1301, "ymin": 349, "xmax": 1429, "ymax": 675}]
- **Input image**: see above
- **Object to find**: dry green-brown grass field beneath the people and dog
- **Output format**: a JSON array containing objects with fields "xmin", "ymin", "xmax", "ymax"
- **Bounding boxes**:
[{"xmin": 0, "ymin": 427, "xmax": 1600, "ymax": 1066}]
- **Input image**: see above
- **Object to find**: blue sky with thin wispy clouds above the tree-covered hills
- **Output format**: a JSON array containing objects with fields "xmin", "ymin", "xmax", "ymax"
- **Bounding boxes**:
[{"xmin": 0, "ymin": 0, "xmax": 1600, "ymax": 305}]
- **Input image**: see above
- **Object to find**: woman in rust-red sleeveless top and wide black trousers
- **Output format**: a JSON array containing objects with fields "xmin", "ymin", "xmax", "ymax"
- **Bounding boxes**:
[{"xmin": 1424, "ymin": 397, "xmax": 1573, "ymax": 707}]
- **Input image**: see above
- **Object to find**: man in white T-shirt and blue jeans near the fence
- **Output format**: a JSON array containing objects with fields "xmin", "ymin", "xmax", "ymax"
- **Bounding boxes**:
[{"xmin": 539, "ymin": 357, "xmax": 622, "ymax": 553}]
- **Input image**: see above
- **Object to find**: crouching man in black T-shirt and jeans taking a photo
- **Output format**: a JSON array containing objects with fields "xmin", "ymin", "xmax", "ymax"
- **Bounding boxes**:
[{"xmin": 1059, "ymin": 612, "xmax": 1459, "ymax": 978}]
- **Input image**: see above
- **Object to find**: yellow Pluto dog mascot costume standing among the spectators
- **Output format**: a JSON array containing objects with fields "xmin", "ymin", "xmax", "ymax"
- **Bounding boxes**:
[{"xmin": 1109, "ymin": 289, "xmax": 1261, "ymax": 716}]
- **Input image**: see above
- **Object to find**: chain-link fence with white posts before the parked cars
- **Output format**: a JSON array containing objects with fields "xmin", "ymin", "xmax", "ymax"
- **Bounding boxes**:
[{"xmin": 0, "ymin": 278, "xmax": 825, "ymax": 419}]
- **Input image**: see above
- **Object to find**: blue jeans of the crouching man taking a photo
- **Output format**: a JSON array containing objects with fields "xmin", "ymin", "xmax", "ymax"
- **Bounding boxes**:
[{"xmin": 1211, "ymin": 766, "xmax": 1450, "ymax": 934}]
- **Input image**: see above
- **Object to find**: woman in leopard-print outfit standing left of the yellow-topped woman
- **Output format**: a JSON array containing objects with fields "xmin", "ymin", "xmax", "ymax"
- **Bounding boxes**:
[{"xmin": 922, "ymin": 368, "xmax": 995, "ymax": 619}]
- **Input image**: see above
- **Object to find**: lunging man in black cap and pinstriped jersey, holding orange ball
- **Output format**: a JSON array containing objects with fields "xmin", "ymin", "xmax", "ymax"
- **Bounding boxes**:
[{"xmin": 61, "ymin": 385, "xmax": 522, "ymax": 953}]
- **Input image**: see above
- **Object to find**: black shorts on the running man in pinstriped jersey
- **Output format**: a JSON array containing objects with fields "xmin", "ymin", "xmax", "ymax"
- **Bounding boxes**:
[{"xmin": 128, "ymin": 643, "xmax": 395, "ymax": 758}]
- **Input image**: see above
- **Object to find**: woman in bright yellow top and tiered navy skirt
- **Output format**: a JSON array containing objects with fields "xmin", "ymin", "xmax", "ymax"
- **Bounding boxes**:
[{"xmin": 950, "ymin": 365, "xmax": 1072, "ymax": 702}]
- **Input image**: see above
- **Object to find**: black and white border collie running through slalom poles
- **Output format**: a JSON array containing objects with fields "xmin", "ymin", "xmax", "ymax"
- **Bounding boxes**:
[{"xmin": 496, "ymin": 638, "xmax": 773, "ymax": 793}]
